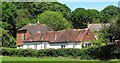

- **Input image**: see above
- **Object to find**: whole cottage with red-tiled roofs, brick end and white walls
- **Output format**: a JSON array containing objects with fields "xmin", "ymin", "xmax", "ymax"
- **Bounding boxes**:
[{"xmin": 16, "ymin": 24, "xmax": 96, "ymax": 50}]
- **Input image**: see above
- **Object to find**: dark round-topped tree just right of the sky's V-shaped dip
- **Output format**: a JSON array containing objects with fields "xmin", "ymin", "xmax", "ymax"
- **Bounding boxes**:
[{"xmin": 71, "ymin": 8, "xmax": 87, "ymax": 28}]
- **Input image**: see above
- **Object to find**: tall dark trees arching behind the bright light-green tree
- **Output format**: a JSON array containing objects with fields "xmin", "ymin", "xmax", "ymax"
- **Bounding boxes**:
[{"xmin": 15, "ymin": 2, "xmax": 71, "ymax": 18}]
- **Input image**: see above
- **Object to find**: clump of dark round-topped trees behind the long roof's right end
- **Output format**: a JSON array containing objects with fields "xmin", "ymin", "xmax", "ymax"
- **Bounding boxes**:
[{"xmin": 71, "ymin": 8, "xmax": 100, "ymax": 28}]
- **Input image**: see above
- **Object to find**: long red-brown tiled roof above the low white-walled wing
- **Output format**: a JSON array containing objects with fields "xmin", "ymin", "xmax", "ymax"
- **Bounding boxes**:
[{"xmin": 25, "ymin": 29, "xmax": 87, "ymax": 42}]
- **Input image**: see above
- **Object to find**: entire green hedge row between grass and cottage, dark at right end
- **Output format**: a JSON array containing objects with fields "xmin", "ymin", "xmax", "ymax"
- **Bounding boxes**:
[{"xmin": 2, "ymin": 46, "xmax": 120, "ymax": 60}]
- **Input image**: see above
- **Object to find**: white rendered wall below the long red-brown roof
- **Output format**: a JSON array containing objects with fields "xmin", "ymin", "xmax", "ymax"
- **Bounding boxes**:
[{"xmin": 20, "ymin": 42, "xmax": 82, "ymax": 50}]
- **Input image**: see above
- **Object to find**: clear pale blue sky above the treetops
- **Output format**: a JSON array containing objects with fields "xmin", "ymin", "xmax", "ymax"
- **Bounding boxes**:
[{"xmin": 59, "ymin": 0, "xmax": 120, "ymax": 11}]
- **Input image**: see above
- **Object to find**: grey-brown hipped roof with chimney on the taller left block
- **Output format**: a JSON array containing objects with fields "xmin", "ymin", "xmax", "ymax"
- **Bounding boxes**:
[{"xmin": 18, "ymin": 23, "xmax": 53, "ymax": 34}]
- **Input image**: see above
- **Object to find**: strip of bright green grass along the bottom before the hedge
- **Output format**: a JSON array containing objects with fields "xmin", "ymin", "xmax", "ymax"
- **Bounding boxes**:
[{"xmin": 2, "ymin": 56, "xmax": 120, "ymax": 63}]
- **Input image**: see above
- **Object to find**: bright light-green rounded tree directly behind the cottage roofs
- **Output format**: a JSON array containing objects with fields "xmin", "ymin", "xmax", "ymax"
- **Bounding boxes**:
[{"xmin": 37, "ymin": 11, "xmax": 72, "ymax": 31}]
